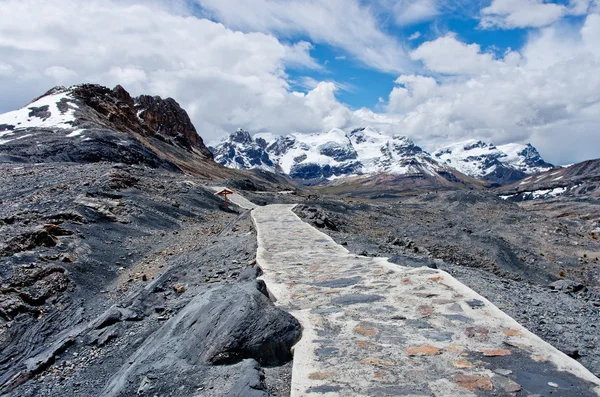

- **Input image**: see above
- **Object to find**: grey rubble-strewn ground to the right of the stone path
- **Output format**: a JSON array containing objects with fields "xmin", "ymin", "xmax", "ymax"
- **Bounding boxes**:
[{"xmin": 296, "ymin": 187, "xmax": 600, "ymax": 375}]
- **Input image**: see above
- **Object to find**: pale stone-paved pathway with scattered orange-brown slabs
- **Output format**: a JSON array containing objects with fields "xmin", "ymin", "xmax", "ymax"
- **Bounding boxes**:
[{"xmin": 252, "ymin": 205, "xmax": 600, "ymax": 397}]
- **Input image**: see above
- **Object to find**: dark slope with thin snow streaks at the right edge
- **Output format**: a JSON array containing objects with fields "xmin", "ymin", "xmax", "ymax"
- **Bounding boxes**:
[{"xmin": 496, "ymin": 159, "xmax": 600, "ymax": 201}]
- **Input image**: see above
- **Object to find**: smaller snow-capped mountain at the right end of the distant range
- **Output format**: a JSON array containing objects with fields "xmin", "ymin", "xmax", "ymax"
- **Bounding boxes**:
[{"xmin": 433, "ymin": 139, "xmax": 554, "ymax": 185}]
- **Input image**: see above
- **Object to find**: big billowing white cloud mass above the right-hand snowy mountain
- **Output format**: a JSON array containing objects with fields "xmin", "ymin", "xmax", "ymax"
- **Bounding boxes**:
[{"xmin": 384, "ymin": 14, "xmax": 600, "ymax": 163}]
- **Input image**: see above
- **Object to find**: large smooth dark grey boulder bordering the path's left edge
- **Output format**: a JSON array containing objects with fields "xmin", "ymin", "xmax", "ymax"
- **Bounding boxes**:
[{"xmin": 101, "ymin": 269, "xmax": 300, "ymax": 396}]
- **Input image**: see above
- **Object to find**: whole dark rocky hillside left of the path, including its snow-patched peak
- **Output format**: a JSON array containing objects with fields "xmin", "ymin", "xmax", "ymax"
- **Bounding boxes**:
[{"xmin": 0, "ymin": 85, "xmax": 300, "ymax": 396}]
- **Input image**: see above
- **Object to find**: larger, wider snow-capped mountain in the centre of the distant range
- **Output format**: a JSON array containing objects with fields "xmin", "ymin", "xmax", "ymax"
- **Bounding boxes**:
[{"xmin": 212, "ymin": 127, "xmax": 448, "ymax": 181}]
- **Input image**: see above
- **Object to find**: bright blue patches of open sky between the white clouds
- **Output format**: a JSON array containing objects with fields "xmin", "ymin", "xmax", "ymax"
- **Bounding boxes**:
[{"xmin": 270, "ymin": 0, "xmax": 585, "ymax": 111}]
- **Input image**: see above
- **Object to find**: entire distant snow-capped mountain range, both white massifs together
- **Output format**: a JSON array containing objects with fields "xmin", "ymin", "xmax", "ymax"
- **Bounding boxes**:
[{"xmin": 210, "ymin": 127, "xmax": 554, "ymax": 186}]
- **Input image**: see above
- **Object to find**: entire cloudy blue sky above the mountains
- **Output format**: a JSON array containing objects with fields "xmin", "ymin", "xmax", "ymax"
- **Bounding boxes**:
[{"xmin": 0, "ymin": 0, "xmax": 600, "ymax": 164}]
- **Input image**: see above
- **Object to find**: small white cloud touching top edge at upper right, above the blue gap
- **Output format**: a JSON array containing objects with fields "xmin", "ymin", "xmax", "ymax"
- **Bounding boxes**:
[{"xmin": 480, "ymin": 0, "xmax": 590, "ymax": 29}]
